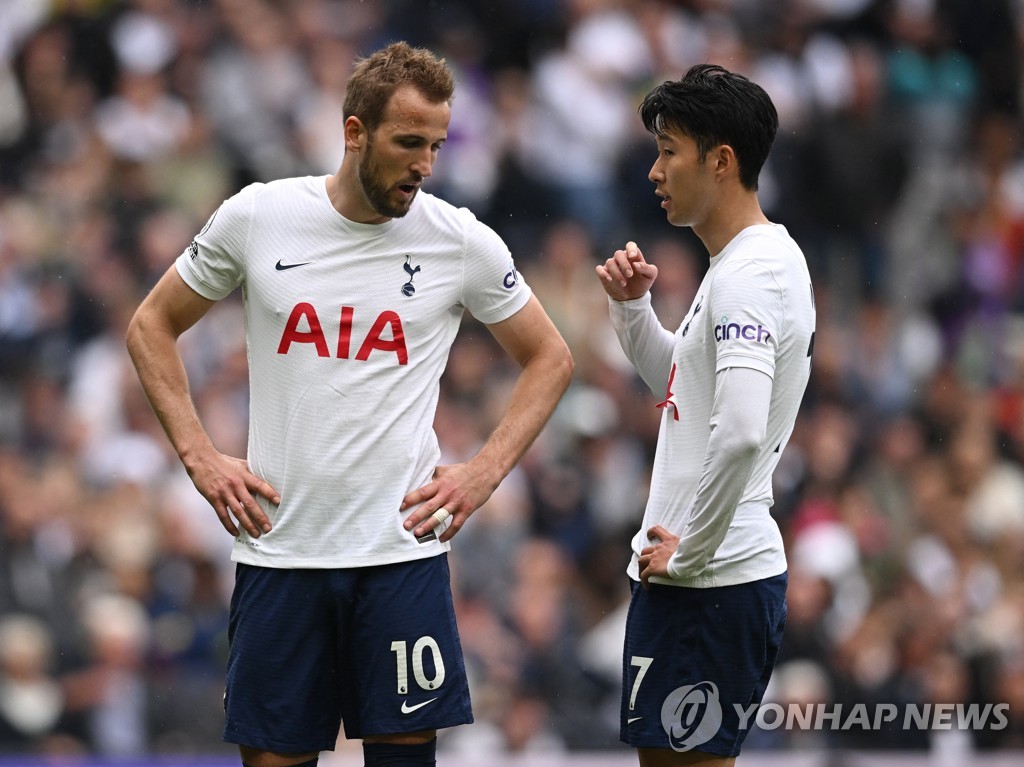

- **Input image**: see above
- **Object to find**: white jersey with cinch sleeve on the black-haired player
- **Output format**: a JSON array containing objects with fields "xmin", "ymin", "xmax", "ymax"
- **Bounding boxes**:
[{"xmin": 612, "ymin": 224, "xmax": 815, "ymax": 588}]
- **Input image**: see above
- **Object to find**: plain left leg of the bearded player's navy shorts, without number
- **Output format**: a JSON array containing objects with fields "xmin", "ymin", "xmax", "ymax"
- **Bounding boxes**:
[{"xmin": 224, "ymin": 564, "xmax": 351, "ymax": 754}]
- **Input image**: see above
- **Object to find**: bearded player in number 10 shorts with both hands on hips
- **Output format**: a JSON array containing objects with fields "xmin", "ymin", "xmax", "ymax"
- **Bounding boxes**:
[{"xmin": 127, "ymin": 42, "xmax": 572, "ymax": 767}]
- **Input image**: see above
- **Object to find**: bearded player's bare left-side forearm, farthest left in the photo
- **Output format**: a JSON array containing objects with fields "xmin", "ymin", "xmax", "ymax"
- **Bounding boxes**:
[{"xmin": 126, "ymin": 310, "xmax": 213, "ymax": 469}]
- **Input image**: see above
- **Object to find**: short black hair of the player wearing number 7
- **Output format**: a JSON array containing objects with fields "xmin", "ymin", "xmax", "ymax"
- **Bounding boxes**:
[{"xmin": 639, "ymin": 63, "xmax": 778, "ymax": 190}]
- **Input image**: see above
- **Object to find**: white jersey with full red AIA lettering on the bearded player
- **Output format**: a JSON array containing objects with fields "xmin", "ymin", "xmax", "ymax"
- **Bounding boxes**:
[{"xmin": 176, "ymin": 176, "xmax": 530, "ymax": 567}]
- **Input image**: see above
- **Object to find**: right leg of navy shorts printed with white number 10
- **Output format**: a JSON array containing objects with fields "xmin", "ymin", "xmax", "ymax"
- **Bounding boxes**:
[{"xmin": 342, "ymin": 554, "xmax": 473, "ymax": 738}]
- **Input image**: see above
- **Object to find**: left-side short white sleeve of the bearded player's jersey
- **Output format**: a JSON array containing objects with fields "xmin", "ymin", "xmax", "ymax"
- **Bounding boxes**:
[{"xmin": 175, "ymin": 186, "xmax": 254, "ymax": 301}]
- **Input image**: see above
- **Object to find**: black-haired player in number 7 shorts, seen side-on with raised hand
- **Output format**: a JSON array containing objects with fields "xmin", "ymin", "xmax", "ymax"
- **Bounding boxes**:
[{"xmin": 597, "ymin": 65, "xmax": 815, "ymax": 767}]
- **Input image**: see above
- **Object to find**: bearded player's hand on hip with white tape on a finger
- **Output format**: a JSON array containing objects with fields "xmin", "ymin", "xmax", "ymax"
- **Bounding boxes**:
[{"xmin": 398, "ymin": 463, "xmax": 498, "ymax": 543}]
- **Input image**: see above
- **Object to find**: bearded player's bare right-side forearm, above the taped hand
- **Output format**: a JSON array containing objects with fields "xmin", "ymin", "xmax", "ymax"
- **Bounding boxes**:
[{"xmin": 475, "ymin": 337, "xmax": 572, "ymax": 487}]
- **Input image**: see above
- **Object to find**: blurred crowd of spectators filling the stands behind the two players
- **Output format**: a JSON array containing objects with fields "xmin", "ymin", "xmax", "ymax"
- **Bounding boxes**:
[{"xmin": 0, "ymin": 0, "xmax": 1024, "ymax": 764}]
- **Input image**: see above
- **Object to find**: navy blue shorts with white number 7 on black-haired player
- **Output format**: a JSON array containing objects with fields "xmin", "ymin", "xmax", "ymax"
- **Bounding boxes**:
[{"xmin": 620, "ymin": 572, "xmax": 788, "ymax": 757}]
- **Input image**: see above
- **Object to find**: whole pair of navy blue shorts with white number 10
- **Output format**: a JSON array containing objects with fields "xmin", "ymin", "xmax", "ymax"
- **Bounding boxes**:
[{"xmin": 224, "ymin": 554, "xmax": 473, "ymax": 754}]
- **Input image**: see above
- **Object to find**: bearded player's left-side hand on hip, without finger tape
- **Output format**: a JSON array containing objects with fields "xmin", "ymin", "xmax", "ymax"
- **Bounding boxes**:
[{"xmin": 188, "ymin": 453, "xmax": 281, "ymax": 538}]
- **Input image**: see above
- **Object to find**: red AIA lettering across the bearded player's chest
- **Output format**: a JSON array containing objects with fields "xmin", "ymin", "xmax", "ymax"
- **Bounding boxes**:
[{"xmin": 278, "ymin": 301, "xmax": 409, "ymax": 365}]
